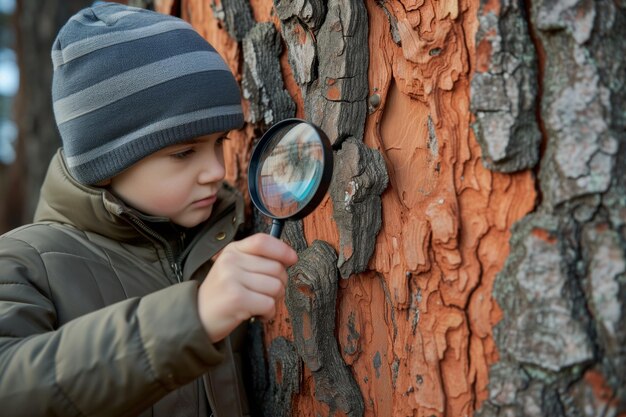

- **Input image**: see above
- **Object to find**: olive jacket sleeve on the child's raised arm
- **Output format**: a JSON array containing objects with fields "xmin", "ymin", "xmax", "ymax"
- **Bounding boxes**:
[{"xmin": 0, "ymin": 237, "xmax": 223, "ymax": 417}]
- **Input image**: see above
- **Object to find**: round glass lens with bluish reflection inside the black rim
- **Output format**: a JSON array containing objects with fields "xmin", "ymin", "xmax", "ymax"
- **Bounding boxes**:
[{"xmin": 257, "ymin": 124, "xmax": 324, "ymax": 218}]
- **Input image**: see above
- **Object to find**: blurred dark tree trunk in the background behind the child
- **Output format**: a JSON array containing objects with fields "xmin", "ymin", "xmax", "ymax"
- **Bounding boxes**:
[{"xmin": 0, "ymin": 0, "xmax": 109, "ymax": 233}]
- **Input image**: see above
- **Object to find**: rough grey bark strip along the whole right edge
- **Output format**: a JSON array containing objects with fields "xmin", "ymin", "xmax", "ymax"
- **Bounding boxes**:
[{"xmin": 479, "ymin": 0, "xmax": 626, "ymax": 416}]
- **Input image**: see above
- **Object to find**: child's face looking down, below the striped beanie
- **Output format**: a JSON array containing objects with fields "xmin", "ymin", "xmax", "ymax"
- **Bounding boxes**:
[{"xmin": 110, "ymin": 132, "xmax": 225, "ymax": 227}]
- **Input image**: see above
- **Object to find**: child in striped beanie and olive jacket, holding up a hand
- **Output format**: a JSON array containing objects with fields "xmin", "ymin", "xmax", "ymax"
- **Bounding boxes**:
[{"xmin": 0, "ymin": 3, "xmax": 297, "ymax": 417}]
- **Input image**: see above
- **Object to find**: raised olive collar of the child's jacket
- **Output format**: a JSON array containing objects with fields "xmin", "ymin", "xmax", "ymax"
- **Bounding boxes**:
[{"xmin": 34, "ymin": 149, "xmax": 243, "ymax": 275}]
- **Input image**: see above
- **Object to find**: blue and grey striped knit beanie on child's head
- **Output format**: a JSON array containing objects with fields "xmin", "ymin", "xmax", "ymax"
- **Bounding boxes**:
[{"xmin": 52, "ymin": 2, "xmax": 243, "ymax": 184}]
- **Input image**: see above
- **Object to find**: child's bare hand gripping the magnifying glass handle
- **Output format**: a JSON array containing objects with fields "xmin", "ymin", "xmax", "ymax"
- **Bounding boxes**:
[{"xmin": 198, "ymin": 233, "xmax": 298, "ymax": 342}]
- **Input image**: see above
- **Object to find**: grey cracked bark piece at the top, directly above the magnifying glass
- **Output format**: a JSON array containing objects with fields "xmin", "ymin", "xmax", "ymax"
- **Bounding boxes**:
[{"xmin": 275, "ymin": 0, "xmax": 368, "ymax": 145}]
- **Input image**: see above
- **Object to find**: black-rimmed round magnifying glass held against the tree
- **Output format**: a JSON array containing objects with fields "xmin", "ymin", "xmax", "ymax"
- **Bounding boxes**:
[{"xmin": 248, "ymin": 119, "xmax": 333, "ymax": 238}]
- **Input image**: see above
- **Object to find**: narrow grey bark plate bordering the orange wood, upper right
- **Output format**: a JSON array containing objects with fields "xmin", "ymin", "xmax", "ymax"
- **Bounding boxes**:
[{"xmin": 471, "ymin": 0, "xmax": 541, "ymax": 172}]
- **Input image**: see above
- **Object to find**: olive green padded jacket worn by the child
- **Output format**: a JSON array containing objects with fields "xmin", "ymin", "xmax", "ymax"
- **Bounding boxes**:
[{"xmin": 0, "ymin": 151, "xmax": 248, "ymax": 417}]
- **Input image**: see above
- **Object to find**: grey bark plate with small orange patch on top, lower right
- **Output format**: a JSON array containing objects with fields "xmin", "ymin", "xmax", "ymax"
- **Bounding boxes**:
[{"xmin": 494, "ymin": 215, "xmax": 593, "ymax": 372}]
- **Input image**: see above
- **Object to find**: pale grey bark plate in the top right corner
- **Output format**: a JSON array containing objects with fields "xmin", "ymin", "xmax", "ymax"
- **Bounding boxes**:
[{"xmin": 532, "ymin": 1, "xmax": 626, "ymax": 208}]
